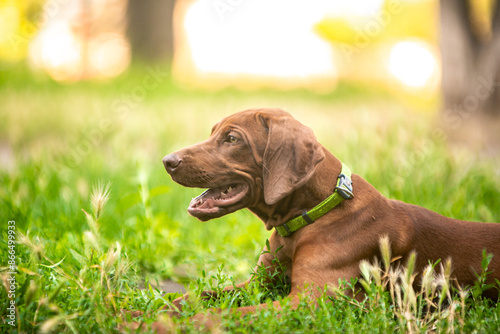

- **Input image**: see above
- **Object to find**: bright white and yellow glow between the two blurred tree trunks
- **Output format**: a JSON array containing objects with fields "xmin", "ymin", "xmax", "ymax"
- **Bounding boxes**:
[{"xmin": 173, "ymin": 0, "xmax": 440, "ymax": 96}]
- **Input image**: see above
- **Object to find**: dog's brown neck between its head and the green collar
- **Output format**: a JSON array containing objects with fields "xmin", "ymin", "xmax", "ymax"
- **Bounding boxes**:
[{"xmin": 249, "ymin": 148, "xmax": 342, "ymax": 230}]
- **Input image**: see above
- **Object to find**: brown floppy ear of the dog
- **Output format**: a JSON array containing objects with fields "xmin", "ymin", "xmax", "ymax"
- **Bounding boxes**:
[{"xmin": 263, "ymin": 116, "xmax": 325, "ymax": 205}]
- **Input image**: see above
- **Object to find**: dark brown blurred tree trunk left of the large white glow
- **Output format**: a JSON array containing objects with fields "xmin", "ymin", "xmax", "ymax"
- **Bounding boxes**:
[{"xmin": 127, "ymin": 0, "xmax": 175, "ymax": 61}]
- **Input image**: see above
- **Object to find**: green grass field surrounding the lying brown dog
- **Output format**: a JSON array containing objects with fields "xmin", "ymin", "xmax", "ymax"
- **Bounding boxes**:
[{"xmin": 0, "ymin": 64, "xmax": 500, "ymax": 333}]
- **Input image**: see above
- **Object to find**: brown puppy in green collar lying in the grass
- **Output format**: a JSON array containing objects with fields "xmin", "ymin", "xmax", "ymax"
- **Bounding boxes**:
[{"xmin": 163, "ymin": 109, "xmax": 500, "ymax": 324}]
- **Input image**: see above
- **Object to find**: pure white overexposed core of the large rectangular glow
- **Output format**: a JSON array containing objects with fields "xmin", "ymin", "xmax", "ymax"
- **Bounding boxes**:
[{"xmin": 185, "ymin": 1, "xmax": 335, "ymax": 77}]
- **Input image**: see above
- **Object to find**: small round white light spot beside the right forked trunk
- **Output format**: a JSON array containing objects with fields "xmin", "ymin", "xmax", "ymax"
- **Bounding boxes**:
[{"xmin": 389, "ymin": 41, "xmax": 438, "ymax": 88}]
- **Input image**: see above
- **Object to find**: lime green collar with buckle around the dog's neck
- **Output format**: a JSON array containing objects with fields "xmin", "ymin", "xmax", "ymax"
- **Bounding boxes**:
[{"xmin": 276, "ymin": 164, "xmax": 354, "ymax": 237}]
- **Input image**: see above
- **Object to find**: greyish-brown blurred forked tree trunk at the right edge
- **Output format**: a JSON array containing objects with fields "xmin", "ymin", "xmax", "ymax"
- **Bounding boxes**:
[{"xmin": 440, "ymin": 0, "xmax": 500, "ymax": 115}]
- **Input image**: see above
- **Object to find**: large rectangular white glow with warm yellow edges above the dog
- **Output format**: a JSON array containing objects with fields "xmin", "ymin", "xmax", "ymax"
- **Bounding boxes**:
[{"xmin": 174, "ymin": 0, "xmax": 365, "ymax": 89}]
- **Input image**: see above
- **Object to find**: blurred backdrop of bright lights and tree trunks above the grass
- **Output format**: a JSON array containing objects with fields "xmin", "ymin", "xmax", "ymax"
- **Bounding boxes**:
[{"xmin": 0, "ymin": 0, "xmax": 500, "ymax": 114}]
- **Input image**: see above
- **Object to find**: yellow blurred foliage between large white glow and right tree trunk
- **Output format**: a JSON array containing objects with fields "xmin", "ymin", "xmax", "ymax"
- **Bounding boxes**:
[{"xmin": 315, "ymin": 0, "xmax": 439, "ymax": 88}]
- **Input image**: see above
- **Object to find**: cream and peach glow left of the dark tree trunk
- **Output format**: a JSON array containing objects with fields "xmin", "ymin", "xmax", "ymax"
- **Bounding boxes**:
[{"xmin": 29, "ymin": 0, "xmax": 131, "ymax": 81}]
